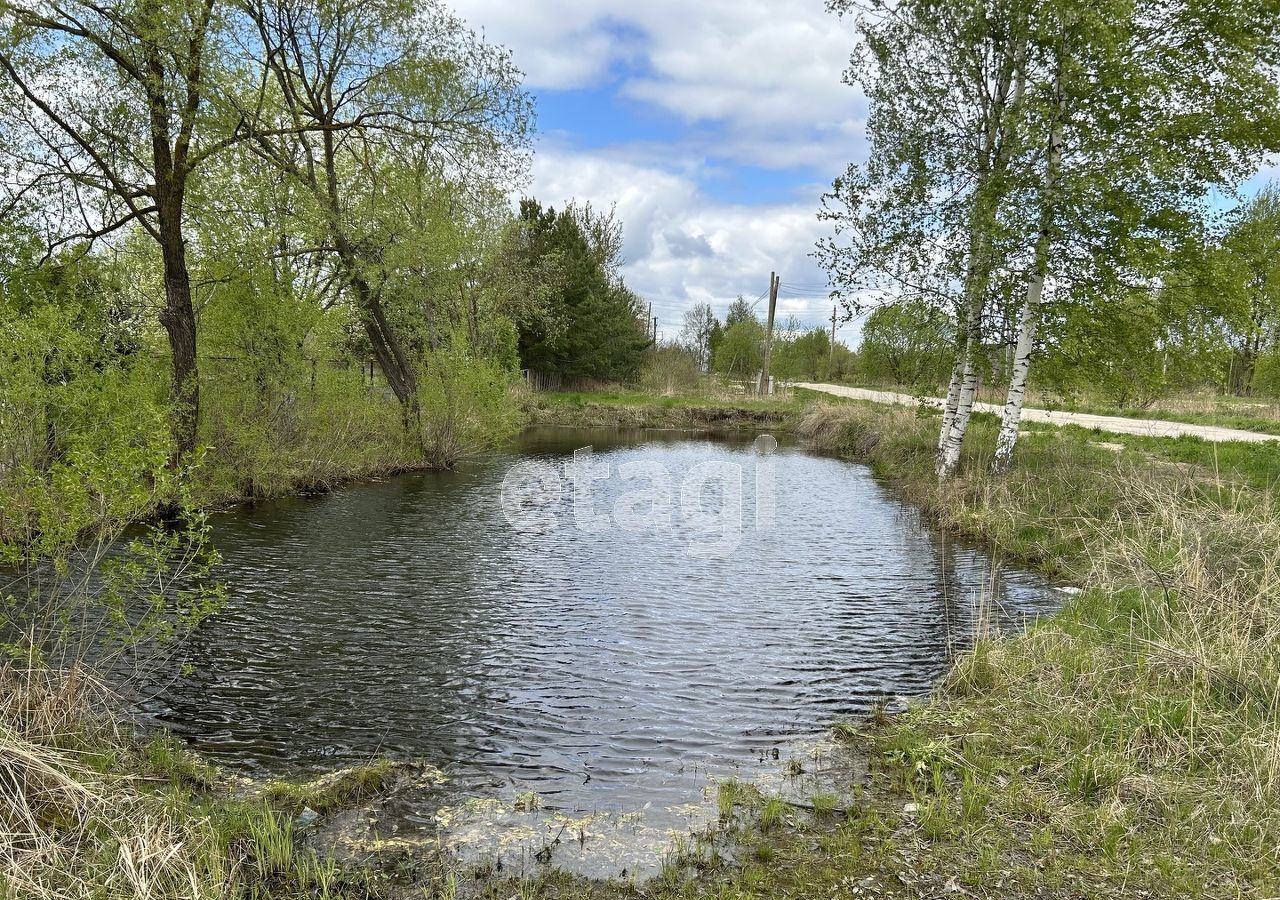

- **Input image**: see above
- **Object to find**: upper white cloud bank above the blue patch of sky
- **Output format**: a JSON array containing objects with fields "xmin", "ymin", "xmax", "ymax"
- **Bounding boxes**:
[{"xmin": 453, "ymin": 0, "xmax": 865, "ymax": 174}]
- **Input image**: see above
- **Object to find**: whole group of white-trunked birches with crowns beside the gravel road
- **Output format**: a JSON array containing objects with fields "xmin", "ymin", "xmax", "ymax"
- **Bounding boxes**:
[{"xmin": 819, "ymin": 0, "xmax": 1280, "ymax": 478}]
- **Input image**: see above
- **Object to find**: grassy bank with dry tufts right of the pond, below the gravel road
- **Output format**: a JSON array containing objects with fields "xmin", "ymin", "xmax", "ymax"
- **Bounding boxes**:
[{"xmin": 489, "ymin": 403, "xmax": 1280, "ymax": 897}]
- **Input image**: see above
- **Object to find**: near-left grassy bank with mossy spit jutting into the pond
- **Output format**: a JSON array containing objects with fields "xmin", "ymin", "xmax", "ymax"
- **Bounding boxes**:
[{"xmin": 0, "ymin": 664, "xmax": 390, "ymax": 900}]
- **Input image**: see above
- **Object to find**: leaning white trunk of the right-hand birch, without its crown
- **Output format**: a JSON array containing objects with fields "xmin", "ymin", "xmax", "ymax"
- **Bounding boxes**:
[{"xmin": 991, "ymin": 84, "xmax": 1062, "ymax": 475}]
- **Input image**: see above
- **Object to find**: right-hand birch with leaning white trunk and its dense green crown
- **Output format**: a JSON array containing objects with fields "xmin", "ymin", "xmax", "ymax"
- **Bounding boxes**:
[{"xmin": 992, "ymin": 0, "xmax": 1280, "ymax": 472}]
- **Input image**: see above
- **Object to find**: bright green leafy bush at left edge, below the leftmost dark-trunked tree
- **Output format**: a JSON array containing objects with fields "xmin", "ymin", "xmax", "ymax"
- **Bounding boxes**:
[{"xmin": 0, "ymin": 260, "xmax": 221, "ymax": 670}]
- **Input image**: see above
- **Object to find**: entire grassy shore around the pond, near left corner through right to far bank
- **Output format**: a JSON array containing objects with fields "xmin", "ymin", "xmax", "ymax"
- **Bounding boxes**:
[{"xmin": 10, "ymin": 393, "xmax": 1280, "ymax": 900}]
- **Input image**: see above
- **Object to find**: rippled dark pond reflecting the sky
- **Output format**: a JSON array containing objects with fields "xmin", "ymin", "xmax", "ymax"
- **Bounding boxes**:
[{"xmin": 154, "ymin": 429, "xmax": 1057, "ymax": 869}]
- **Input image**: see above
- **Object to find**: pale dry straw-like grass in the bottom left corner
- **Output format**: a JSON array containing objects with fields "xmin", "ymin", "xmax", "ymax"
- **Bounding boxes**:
[{"xmin": 0, "ymin": 666, "xmax": 232, "ymax": 900}]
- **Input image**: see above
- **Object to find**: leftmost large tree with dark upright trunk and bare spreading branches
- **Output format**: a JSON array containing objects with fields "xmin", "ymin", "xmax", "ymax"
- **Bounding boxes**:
[{"xmin": 0, "ymin": 0, "xmax": 238, "ymax": 456}]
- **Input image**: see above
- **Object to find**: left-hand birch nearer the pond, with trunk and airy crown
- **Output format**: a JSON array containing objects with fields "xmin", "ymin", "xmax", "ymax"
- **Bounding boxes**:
[{"xmin": 818, "ymin": 0, "xmax": 1028, "ymax": 475}]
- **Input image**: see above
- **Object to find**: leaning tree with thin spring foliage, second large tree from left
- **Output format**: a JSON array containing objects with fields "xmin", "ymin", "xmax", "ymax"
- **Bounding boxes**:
[{"xmin": 235, "ymin": 0, "xmax": 531, "ymax": 424}]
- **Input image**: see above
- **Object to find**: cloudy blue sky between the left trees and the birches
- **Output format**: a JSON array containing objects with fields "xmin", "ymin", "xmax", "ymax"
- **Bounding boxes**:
[{"xmin": 451, "ymin": 0, "xmax": 865, "ymax": 341}]
